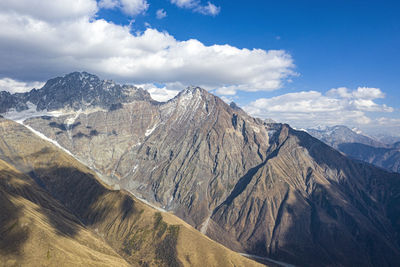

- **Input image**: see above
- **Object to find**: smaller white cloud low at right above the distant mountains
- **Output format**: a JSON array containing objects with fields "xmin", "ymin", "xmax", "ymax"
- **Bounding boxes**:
[{"xmin": 244, "ymin": 87, "xmax": 394, "ymax": 128}]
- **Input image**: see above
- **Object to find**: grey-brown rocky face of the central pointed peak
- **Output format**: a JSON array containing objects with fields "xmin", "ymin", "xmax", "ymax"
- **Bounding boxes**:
[{"xmin": 26, "ymin": 88, "xmax": 269, "ymax": 232}]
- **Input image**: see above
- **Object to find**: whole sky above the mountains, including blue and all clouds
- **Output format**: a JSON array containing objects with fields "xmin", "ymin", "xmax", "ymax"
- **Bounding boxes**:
[{"xmin": 0, "ymin": 0, "xmax": 400, "ymax": 132}]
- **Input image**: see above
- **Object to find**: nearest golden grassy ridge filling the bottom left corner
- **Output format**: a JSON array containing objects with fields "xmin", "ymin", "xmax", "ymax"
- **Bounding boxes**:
[{"xmin": 0, "ymin": 160, "xmax": 128, "ymax": 266}]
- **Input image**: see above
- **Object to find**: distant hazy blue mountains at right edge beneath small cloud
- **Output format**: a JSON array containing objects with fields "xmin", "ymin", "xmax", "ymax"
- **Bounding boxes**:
[{"xmin": 307, "ymin": 126, "xmax": 400, "ymax": 172}]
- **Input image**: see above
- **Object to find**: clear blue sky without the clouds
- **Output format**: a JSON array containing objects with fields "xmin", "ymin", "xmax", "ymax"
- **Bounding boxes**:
[{"xmin": 99, "ymin": 0, "xmax": 400, "ymax": 105}]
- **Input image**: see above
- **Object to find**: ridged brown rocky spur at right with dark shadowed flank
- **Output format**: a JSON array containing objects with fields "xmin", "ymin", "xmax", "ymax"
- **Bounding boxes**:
[{"xmin": 209, "ymin": 125, "xmax": 400, "ymax": 266}]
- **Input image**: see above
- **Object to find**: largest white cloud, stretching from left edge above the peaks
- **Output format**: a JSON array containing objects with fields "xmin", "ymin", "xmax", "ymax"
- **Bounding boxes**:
[{"xmin": 0, "ymin": 0, "xmax": 294, "ymax": 95}]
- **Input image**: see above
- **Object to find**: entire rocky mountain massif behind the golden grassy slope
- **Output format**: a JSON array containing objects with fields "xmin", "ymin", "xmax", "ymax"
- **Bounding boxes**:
[{"xmin": 0, "ymin": 73, "xmax": 400, "ymax": 266}]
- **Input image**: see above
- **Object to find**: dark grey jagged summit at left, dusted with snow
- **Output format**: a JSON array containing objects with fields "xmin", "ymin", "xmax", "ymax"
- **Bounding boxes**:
[{"xmin": 0, "ymin": 72, "xmax": 151, "ymax": 113}]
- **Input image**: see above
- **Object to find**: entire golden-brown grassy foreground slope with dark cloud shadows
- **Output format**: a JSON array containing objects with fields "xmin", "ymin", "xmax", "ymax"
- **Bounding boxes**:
[{"xmin": 0, "ymin": 118, "xmax": 261, "ymax": 266}]
